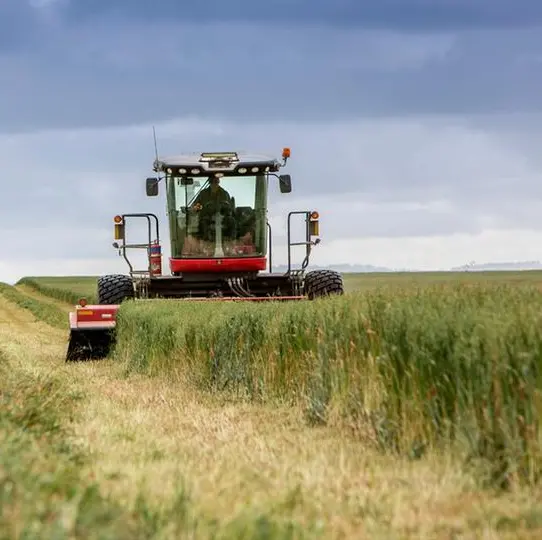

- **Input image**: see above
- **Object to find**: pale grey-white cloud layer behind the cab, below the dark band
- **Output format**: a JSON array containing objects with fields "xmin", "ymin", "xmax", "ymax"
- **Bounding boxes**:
[{"xmin": 0, "ymin": 118, "xmax": 542, "ymax": 258}]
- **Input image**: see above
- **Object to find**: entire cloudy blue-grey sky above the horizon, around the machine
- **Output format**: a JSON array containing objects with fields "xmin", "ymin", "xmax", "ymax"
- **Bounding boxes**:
[{"xmin": 0, "ymin": 0, "xmax": 542, "ymax": 281}]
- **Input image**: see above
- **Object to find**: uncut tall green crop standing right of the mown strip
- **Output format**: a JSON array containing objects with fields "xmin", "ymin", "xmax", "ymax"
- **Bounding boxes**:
[{"xmin": 116, "ymin": 284, "xmax": 542, "ymax": 487}]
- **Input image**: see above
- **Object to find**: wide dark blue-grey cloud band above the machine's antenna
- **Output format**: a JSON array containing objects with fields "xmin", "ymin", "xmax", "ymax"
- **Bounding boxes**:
[{"xmin": 0, "ymin": 25, "xmax": 542, "ymax": 131}]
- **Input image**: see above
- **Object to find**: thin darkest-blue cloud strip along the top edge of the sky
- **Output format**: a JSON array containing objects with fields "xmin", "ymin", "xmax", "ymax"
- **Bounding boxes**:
[{"xmin": 60, "ymin": 0, "xmax": 542, "ymax": 30}]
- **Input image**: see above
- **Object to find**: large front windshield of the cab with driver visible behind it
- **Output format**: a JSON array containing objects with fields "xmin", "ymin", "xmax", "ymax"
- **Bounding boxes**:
[{"xmin": 168, "ymin": 175, "xmax": 267, "ymax": 258}]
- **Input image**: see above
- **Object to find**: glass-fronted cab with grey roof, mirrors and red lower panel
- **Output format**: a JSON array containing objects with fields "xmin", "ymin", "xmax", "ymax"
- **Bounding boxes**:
[{"xmin": 147, "ymin": 149, "xmax": 291, "ymax": 274}]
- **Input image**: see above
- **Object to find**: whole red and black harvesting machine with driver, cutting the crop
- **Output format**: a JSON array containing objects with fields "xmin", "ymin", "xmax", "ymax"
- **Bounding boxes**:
[{"xmin": 66, "ymin": 148, "xmax": 343, "ymax": 361}]
